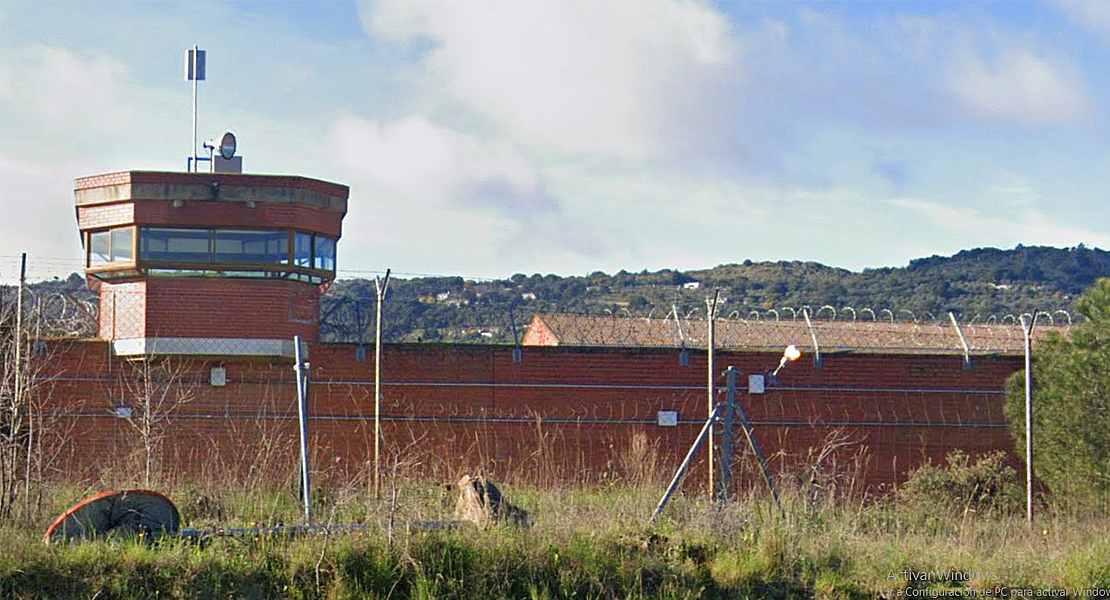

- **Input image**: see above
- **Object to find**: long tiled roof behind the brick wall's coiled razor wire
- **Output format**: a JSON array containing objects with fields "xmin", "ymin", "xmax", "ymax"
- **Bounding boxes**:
[{"xmin": 525, "ymin": 314, "xmax": 1068, "ymax": 355}]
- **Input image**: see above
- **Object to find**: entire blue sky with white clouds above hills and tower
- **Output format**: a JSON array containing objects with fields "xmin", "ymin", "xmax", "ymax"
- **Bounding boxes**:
[{"xmin": 0, "ymin": 0, "xmax": 1110, "ymax": 282}]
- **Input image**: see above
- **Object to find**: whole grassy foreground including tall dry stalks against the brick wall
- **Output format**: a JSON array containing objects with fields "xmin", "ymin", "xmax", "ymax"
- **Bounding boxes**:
[{"xmin": 0, "ymin": 419, "xmax": 1110, "ymax": 600}]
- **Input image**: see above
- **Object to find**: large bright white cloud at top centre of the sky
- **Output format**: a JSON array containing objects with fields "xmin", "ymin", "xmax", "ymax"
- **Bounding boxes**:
[{"xmin": 361, "ymin": 0, "xmax": 738, "ymax": 157}]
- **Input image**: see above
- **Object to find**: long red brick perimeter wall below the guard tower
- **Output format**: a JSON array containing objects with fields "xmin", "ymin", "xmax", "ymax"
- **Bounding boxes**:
[{"xmin": 37, "ymin": 342, "xmax": 1020, "ymax": 489}]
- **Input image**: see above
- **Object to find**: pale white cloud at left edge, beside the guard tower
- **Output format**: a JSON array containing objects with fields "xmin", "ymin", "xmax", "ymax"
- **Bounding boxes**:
[{"xmin": 0, "ymin": 44, "xmax": 164, "ymax": 275}]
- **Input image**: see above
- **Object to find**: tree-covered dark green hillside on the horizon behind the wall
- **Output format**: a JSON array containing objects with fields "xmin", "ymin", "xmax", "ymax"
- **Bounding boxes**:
[{"xmin": 0, "ymin": 245, "xmax": 1110, "ymax": 344}]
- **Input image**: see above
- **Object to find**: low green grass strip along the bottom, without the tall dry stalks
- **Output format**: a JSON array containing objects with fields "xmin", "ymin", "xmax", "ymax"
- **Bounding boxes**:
[{"xmin": 0, "ymin": 480, "xmax": 1110, "ymax": 600}]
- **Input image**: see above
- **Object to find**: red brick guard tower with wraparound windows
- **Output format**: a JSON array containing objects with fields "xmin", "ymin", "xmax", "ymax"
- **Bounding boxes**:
[{"xmin": 73, "ymin": 171, "xmax": 350, "ymax": 357}]
